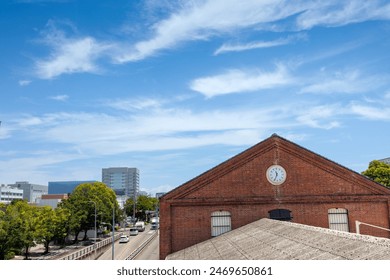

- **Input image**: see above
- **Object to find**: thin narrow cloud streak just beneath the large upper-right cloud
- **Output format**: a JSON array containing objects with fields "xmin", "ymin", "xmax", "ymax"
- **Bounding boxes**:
[{"xmin": 214, "ymin": 34, "xmax": 306, "ymax": 55}]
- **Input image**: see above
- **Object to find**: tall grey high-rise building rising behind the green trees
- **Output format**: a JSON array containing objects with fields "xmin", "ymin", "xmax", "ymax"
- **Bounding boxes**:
[{"xmin": 102, "ymin": 167, "xmax": 139, "ymax": 198}]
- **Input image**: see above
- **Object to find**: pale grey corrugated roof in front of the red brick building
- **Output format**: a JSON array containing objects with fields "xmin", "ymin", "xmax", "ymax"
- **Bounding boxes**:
[{"xmin": 166, "ymin": 218, "xmax": 390, "ymax": 260}]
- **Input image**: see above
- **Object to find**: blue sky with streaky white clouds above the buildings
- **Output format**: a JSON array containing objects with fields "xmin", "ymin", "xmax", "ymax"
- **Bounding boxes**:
[{"xmin": 0, "ymin": 0, "xmax": 390, "ymax": 194}]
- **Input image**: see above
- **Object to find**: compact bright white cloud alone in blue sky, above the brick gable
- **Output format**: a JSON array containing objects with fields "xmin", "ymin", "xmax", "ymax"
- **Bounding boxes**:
[{"xmin": 190, "ymin": 65, "xmax": 293, "ymax": 97}]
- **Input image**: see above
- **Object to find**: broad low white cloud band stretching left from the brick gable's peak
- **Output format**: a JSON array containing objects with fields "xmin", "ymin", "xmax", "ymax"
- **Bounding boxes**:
[{"xmin": 6, "ymin": 103, "xmax": 288, "ymax": 156}]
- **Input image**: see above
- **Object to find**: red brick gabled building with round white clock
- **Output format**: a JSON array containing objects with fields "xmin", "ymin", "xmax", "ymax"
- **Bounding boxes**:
[{"xmin": 160, "ymin": 134, "xmax": 390, "ymax": 259}]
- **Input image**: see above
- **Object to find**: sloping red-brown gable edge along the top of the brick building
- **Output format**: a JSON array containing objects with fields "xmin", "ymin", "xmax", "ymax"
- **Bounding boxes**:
[{"xmin": 160, "ymin": 134, "xmax": 390, "ymax": 200}]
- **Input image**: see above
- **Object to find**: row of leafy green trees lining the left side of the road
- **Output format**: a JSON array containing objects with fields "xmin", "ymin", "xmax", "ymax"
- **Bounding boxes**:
[{"xmin": 0, "ymin": 182, "xmax": 158, "ymax": 260}]
